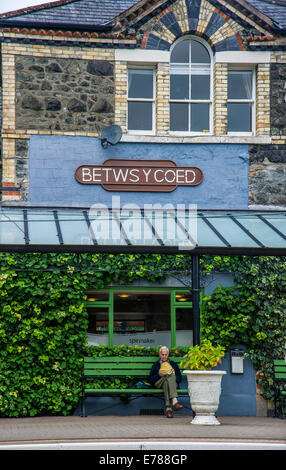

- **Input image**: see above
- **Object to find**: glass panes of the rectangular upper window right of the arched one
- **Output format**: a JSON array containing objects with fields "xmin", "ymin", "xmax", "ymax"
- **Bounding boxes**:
[{"xmin": 227, "ymin": 70, "xmax": 255, "ymax": 134}]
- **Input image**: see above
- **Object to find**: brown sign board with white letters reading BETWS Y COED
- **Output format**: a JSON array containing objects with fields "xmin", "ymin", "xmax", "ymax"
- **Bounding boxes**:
[{"xmin": 75, "ymin": 159, "xmax": 203, "ymax": 192}]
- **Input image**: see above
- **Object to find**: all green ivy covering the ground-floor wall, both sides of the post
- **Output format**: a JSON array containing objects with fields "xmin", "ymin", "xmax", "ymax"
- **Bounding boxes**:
[{"xmin": 0, "ymin": 253, "xmax": 286, "ymax": 417}]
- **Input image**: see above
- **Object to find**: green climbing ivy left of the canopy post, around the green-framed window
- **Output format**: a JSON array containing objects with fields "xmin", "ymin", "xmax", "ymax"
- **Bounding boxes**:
[{"xmin": 0, "ymin": 253, "xmax": 189, "ymax": 417}]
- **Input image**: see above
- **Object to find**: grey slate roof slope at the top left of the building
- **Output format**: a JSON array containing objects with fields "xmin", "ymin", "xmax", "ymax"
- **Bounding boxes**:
[{"xmin": 0, "ymin": 0, "xmax": 138, "ymax": 27}]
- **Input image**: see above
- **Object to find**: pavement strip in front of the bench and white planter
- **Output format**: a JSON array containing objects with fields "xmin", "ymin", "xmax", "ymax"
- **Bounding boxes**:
[{"xmin": 0, "ymin": 414, "xmax": 286, "ymax": 450}]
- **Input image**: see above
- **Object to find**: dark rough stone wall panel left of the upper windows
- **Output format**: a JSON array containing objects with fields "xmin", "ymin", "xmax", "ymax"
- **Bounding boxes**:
[{"xmin": 15, "ymin": 56, "xmax": 114, "ymax": 133}]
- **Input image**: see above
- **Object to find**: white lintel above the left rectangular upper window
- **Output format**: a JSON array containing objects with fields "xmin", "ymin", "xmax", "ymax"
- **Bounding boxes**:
[{"xmin": 115, "ymin": 49, "xmax": 170, "ymax": 64}]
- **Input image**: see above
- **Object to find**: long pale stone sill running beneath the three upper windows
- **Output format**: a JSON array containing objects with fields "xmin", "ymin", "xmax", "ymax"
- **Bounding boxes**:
[{"xmin": 121, "ymin": 134, "xmax": 271, "ymax": 144}]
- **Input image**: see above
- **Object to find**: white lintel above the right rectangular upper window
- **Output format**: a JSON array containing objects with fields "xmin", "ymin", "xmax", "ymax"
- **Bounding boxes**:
[{"xmin": 214, "ymin": 51, "xmax": 271, "ymax": 64}]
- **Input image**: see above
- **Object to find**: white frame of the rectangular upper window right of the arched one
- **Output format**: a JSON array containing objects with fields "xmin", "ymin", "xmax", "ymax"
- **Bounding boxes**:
[{"xmin": 227, "ymin": 64, "xmax": 256, "ymax": 136}]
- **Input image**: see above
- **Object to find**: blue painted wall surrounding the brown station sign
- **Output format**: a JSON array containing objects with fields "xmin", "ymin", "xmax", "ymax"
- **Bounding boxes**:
[{"xmin": 28, "ymin": 135, "xmax": 248, "ymax": 209}]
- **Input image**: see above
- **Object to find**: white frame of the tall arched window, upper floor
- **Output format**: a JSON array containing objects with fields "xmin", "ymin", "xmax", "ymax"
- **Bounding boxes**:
[{"xmin": 169, "ymin": 36, "xmax": 214, "ymax": 136}]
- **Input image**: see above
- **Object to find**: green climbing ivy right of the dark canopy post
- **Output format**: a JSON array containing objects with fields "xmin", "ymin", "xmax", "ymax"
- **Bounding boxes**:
[{"xmin": 202, "ymin": 253, "xmax": 286, "ymax": 399}]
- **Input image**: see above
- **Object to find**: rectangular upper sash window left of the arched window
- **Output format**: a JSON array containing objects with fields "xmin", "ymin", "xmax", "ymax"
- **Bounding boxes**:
[{"xmin": 127, "ymin": 68, "xmax": 155, "ymax": 134}]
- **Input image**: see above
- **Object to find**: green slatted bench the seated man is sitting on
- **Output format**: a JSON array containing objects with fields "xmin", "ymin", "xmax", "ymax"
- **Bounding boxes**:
[{"xmin": 81, "ymin": 356, "xmax": 188, "ymax": 416}]
